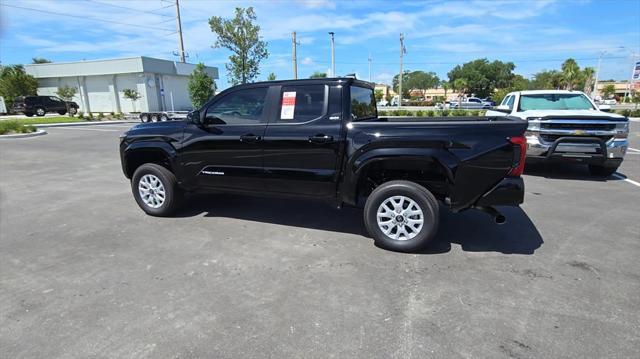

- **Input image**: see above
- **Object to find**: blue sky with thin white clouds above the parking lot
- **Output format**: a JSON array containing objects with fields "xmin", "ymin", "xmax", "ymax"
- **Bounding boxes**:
[{"xmin": 0, "ymin": 0, "xmax": 640, "ymax": 88}]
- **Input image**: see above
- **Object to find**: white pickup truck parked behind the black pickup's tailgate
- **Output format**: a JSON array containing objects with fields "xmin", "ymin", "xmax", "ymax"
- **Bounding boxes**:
[{"xmin": 486, "ymin": 90, "xmax": 629, "ymax": 176}]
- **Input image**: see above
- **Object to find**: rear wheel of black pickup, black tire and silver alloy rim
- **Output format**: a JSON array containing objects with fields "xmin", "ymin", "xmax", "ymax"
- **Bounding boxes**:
[{"xmin": 364, "ymin": 181, "xmax": 439, "ymax": 252}]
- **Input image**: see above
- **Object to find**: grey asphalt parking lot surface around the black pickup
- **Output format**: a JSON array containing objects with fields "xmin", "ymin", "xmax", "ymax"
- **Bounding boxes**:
[{"xmin": 0, "ymin": 122, "xmax": 640, "ymax": 358}]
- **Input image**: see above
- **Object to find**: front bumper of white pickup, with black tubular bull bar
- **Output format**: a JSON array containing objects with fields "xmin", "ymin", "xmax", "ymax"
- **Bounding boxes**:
[{"xmin": 527, "ymin": 135, "xmax": 629, "ymax": 164}]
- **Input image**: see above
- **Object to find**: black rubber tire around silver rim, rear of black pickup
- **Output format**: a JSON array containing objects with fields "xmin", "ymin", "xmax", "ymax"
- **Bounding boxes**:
[{"xmin": 364, "ymin": 181, "xmax": 440, "ymax": 252}]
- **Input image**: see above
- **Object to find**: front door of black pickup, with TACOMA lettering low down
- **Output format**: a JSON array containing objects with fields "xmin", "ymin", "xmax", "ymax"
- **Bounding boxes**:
[{"xmin": 181, "ymin": 86, "xmax": 269, "ymax": 191}]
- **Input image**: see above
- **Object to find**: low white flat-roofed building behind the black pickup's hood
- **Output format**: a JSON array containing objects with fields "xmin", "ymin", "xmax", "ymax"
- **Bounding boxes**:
[{"xmin": 25, "ymin": 56, "xmax": 218, "ymax": 112}]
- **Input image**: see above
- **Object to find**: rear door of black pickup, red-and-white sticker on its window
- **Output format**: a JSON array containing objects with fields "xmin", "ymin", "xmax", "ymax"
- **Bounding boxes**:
[{"xmin": 264, "ymin": 84, "xmax": 342, "ymax": 197}]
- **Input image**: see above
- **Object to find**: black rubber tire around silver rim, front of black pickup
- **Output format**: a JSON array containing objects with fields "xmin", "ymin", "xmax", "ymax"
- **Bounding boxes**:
[{"xmin": 131, "ymin": 163, "xmax": 182, "ymax": 217}]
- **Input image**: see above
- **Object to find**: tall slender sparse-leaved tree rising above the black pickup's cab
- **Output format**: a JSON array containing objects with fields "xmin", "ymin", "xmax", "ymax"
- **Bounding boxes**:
[{"xmin": 209, "ymin": 7, "xmax": 269, "ymax": 85}]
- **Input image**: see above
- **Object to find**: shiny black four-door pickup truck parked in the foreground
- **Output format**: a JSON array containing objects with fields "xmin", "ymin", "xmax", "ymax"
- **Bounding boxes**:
[{"xmin": 120, "ymin": 78, "xmax": 527, "ymax": 251}]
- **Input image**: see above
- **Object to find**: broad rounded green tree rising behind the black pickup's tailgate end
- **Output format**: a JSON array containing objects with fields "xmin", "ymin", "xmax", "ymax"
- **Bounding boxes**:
[{"xmin": 447, "ymin": 59, "xmax": 515, "ymax": 97}]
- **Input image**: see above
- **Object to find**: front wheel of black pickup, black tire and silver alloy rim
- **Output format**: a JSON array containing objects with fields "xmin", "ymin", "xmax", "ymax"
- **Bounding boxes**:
[{"xmin": 131, "ymin": 163, "xmax": 182, "ymax": 217}]
